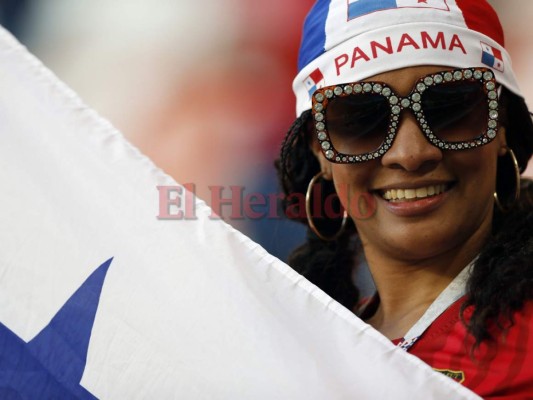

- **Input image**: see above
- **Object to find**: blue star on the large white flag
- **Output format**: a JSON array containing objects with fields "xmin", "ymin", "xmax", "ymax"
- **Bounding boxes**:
[{"xmin": 0, "ymin": 259, "xmax": 112, "ymax": 400}]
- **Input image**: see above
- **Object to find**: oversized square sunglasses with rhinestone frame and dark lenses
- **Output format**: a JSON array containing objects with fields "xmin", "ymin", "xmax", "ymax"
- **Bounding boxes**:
[{"xmin": 312, "ymin": 68, "xmax": 498, "ymax": 163}]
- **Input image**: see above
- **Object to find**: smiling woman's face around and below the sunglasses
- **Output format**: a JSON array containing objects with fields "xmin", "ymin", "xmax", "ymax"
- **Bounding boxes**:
[{"xmin": 314, "ymin": 66, "xmax": 505, "ymax": 262}]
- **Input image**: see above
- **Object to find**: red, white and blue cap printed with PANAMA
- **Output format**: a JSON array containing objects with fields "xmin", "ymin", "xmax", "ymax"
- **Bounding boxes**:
[{"xmin": 293, "ymin": 0, "xmax": 521, "ymax": 116}]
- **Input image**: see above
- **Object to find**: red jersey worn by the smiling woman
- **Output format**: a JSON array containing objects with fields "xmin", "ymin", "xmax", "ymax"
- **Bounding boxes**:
[{"xmin": 409, "ymin": 297, "xmax": 533, "ymax": 400}]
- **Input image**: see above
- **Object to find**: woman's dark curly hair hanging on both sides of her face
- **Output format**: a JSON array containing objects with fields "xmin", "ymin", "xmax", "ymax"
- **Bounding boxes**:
[{"xmin": 276, "ymin": 87, "xmax": 533, "ymax": 346}]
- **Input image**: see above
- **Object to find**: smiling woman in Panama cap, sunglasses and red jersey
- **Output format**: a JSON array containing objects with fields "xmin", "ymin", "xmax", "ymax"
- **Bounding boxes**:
[{"xmin": 278, "ymin": 0, "xmax": 533, "ymax": 399}]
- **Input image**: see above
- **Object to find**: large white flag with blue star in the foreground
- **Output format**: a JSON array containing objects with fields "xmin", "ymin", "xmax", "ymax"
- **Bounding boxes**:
[{"xmin": 0, "ymin": 26, "xmax": 478, "ymax": 400}]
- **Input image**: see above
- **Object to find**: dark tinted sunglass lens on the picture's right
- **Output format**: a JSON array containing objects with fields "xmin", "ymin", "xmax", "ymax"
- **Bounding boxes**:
[{"xmin": 422, "ymin": 81, "xmax": 488, "ymax": 142}]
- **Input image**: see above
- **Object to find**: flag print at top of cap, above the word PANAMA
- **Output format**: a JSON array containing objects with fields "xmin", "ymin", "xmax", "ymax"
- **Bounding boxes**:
[{"xmin": 348, "ymin": 0, "xmax": 449, "ymax": 20}]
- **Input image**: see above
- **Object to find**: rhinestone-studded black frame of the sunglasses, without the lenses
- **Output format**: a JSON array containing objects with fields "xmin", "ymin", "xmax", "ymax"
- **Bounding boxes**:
[{"xmin": 311, "ymin": 68, "xmax": 499, "ymax": 164}]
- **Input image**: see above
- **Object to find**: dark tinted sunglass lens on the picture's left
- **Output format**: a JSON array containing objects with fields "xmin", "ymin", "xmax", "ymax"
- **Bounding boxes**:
[{"xmin": 325, "ymin": 94, "xmax": 390, "ymax": 155}]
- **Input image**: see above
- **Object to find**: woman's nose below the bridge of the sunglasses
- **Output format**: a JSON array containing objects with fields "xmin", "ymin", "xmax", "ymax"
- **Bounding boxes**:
[{"xmin": 381, "ymin": 112, "xmax": 442, "ymax": 171}]
